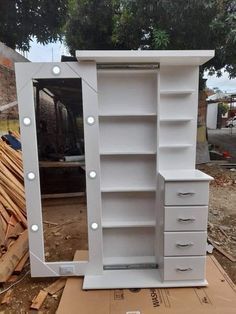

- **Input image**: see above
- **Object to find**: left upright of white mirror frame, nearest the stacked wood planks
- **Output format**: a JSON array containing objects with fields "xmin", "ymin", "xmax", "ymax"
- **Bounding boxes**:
[{"xmin": 16, "ymin": 77, "xmax": 44, "ymax": 264}]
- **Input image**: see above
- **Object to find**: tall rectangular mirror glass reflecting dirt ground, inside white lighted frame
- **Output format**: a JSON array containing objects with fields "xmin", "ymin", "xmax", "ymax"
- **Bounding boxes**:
[{"xmin": 33, "ymin": 78, "xmax": 88, "ymax": 262}]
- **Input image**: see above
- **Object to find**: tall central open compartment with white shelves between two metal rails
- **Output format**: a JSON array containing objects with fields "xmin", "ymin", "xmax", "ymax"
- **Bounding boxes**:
[{"xmin": 98, "ymin": 69, "xmax": 158, "ymax": 280}]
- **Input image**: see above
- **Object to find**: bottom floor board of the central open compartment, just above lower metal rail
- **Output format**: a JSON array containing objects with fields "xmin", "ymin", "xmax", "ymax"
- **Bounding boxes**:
[{"xmin": 103, "ymin": 256, "xmax": 156, "ymax": 265}]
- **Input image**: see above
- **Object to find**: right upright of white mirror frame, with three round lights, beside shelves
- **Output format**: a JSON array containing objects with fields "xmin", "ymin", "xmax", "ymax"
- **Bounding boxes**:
[{"xmin": 82, "ymin": 63, "xmax": 103, "ymax": 275}]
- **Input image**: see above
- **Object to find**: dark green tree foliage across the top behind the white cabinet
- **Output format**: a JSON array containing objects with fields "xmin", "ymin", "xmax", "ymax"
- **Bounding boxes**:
[{"xmin": 0, "ymin": 0, "xmax": 236, "ymax": 81}]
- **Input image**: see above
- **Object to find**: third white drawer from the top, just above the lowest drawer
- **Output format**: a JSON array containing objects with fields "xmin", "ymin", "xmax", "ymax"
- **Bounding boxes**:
[{"xmin": 164, "ymin": 231, "xmax": 207, "ymax": 256}]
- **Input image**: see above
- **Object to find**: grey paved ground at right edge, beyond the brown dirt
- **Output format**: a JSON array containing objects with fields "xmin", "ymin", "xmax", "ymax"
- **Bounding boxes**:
[{"xmin": 208, "ymin": 127, "xmax": 236, "ymax": 162}]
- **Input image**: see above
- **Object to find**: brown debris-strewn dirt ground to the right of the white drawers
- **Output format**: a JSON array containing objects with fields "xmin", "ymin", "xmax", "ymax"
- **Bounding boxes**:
[{"xmin": 198, "ymin": 164, "xmax": 236, "ymax": 284}]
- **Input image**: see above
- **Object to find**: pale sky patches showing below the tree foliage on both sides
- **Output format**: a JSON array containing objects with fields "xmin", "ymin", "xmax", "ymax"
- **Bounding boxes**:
[{"xmin": 25, "ymin": 39, "xmax": 236, "ymax": 93}]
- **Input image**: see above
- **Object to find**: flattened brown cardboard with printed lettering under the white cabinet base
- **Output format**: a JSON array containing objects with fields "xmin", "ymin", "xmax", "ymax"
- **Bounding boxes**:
[{"xmin": 57, "ymin": 252, "xmax": 236, "ymax": 314}]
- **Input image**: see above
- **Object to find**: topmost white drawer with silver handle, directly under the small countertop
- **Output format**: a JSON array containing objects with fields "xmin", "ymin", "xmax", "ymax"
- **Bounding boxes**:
[{"xmin": 165, "ymin": 181, "xmax": 209, "ymax": 205}]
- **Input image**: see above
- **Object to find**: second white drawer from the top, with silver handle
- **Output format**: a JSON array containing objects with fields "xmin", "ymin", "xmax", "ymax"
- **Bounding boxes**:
[{"xmin": 165, "ymin": 206, "xmax": 208, "ymax": 231}]
